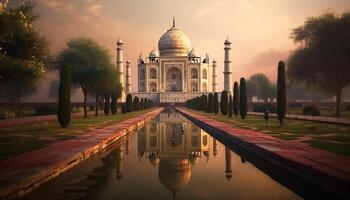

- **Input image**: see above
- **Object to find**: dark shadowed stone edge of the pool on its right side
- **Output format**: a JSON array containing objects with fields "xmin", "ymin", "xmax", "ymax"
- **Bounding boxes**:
[{"xmin": 176, "ymin": 107, "xmax": 350, "ymax": 199}]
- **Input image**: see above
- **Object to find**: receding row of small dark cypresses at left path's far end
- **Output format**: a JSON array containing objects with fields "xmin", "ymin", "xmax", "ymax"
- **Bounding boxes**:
[{"xmin": 122, "ymin": 94, "xmax": 154, "ymax": 113}]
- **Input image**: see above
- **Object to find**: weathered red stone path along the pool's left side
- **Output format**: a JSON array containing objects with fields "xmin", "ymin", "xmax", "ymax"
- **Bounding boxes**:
[{"xmin": 0, "ymin": 108, "xmax": 163, "ymax": 199}]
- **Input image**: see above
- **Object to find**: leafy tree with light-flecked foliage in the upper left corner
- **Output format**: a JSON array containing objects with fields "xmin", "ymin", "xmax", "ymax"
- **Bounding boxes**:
[{"xmin": 0, "ymin": 1, "xmax": 50, "ymax": 111}]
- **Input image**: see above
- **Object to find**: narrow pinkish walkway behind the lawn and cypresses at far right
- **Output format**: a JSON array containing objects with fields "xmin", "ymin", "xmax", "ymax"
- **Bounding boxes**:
[{"xmin": 248, "ymin": 112, "xmax": 350, "ymax": 125}]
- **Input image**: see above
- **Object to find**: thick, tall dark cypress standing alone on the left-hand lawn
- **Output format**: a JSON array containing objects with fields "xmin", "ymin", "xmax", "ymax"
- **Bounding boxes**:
[{"xmin": 57, "ymin": 64, "xmax": 71, "ymax": 127}]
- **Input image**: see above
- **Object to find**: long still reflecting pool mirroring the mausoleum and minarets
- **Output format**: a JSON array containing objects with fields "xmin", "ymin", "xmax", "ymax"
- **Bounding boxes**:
[{"xmin": 25, "ymin": 111, "xmax": 301, "ymax": 200}]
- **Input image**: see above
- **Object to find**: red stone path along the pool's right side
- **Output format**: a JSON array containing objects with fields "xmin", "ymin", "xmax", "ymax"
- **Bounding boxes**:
[{"xmin": 177, "ymin": 108, "xmax": 350, "ymax": 196}]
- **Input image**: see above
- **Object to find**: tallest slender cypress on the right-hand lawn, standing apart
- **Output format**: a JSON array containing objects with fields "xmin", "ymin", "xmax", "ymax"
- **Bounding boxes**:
[{"xmin": 277, "ymin": 61, "xmax": 287, "ymax": 126}]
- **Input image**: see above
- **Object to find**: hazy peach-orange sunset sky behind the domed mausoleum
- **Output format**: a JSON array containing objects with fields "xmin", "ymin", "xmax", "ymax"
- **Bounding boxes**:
[{"xmin": 17, "ymin": 0, "xmax": 350, "ymax": 100}]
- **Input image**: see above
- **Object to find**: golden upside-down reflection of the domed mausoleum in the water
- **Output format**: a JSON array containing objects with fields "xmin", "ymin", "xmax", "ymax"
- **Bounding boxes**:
[{"xmin": 137, "ymin": 113, "xmax": 210, "ymax": 197}]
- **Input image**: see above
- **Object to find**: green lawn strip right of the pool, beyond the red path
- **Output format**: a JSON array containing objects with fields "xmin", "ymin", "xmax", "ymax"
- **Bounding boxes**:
[{"xmin": 187, "ymin": 110, "xmax": 350, "ymax": 156}]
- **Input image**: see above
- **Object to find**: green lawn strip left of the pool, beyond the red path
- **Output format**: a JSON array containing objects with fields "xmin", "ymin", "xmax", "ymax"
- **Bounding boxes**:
[{"xmin": 0, "ymin": 109, "xmax": 152, "ymax": 159}]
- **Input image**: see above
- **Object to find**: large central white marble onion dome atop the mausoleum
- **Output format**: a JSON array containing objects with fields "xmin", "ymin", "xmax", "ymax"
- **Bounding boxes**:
[{"xmin": 158, "ymin": 23, "xmax": 191, "ymax": 56}]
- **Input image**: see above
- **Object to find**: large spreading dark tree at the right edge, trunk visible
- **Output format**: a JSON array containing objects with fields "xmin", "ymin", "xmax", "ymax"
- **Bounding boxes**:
[{"xmin": 287, "ymin": 11, "xmax": 350, "ymax": 117}]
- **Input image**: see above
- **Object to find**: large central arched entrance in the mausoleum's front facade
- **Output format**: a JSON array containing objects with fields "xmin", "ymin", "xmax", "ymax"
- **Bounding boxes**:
[{"xmin": 166, "ymin": 67, "xmax": 182, "ymax": 92}]
